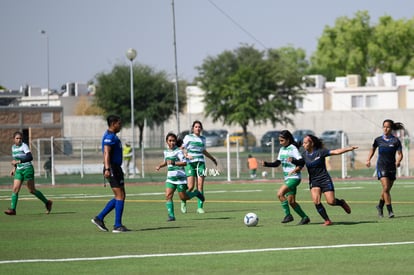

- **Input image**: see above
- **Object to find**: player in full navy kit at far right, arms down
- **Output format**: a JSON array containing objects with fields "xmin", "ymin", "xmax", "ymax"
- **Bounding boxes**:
[{"xmin": 366, "ymin": 119, "xmax": 404, "ymax": 218}]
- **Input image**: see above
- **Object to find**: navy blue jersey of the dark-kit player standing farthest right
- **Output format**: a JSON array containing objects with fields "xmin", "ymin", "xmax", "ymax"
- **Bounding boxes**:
[{"xmin": 372, "ymin": 135, "xmax": 402, "ymax": 171}]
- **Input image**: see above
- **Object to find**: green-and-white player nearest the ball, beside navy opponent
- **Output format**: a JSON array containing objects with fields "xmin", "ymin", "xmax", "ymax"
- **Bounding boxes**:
[{"xmin": 262, "ymin": 130, "xmax": 310, "ymax": 225}]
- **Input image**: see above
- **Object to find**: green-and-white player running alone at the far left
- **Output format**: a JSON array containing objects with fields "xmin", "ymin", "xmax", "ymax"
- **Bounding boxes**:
[{"xmin": 4, "ymin": 132, "xmax": 52, "ymax": 215}]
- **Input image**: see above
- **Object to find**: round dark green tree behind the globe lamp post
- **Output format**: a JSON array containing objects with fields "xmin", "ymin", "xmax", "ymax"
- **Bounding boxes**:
[{"xmin": 95, "ymin": 64, "xmax": 185, "ymax": 147}]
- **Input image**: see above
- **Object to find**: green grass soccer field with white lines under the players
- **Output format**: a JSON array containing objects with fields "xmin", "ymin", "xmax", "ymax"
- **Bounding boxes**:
[{"xmin": 0, "ymin": 179, "xmax": 414, "ymax": 274}]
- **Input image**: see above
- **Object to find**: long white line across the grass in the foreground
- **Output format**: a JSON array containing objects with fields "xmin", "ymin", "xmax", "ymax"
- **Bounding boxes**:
[{"xmin": 0, "ymin": 241, "xmax": 414, "ymax": 264}]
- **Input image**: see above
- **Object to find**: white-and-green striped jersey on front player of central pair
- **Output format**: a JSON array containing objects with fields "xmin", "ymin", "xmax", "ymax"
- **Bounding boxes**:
[{"xmin": 164, "ymin": 147, "xmax": 187, "ymax": 185}]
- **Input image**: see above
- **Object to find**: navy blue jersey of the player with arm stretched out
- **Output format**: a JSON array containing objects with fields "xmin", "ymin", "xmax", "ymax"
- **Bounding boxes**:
[{"xmin": 302, "ymin": 148, "xmax": 332, "ymax": 183}]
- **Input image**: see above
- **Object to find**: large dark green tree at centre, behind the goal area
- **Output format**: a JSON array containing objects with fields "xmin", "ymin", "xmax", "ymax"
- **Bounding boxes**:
[{"xmin": 196, "ymin": 45, "xmax": 307, "ymax": 150}]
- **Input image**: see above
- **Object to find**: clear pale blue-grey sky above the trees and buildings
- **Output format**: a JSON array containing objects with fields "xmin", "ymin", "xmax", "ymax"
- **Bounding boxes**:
[{"xmin": 0, "ymin": 0, "xmax": 414, "ymax": 89}]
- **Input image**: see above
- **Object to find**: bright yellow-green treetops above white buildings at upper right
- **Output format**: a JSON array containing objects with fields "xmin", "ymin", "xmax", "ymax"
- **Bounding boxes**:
[{"xmin": 309, "ymin": 11, "xmax": 414, "ymax": 82}]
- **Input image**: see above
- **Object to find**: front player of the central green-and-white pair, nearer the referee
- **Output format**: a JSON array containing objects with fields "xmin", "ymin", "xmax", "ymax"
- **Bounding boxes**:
[{"xmin": 155, "ymin": 133, "xmax": 204, "ymax": 222}]
